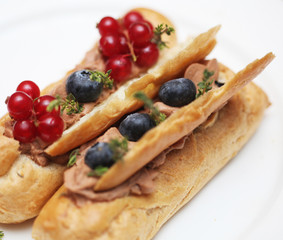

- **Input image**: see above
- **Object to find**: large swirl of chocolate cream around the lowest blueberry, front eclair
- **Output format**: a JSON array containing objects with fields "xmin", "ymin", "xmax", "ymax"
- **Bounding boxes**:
[{"xmin": 64, "ymin": 127, "xmax": 190, "ymax": 206}]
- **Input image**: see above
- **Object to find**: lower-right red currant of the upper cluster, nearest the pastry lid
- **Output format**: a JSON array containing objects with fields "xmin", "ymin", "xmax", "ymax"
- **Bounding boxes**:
[{"xmin": 135, "ymin": 42, "xmax": 159, "ymax": 67}]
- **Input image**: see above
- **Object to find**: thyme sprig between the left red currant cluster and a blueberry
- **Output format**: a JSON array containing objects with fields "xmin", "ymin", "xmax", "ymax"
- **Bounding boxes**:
[{"xmin": 46, "ymin": 93, "xmax": 84, "ymax": 115}]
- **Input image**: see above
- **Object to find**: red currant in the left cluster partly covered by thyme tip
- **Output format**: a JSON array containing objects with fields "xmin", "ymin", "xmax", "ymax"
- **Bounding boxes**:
[{"xmin": 33, "ymin": 95, "xmax": 60, "ymax": 118}]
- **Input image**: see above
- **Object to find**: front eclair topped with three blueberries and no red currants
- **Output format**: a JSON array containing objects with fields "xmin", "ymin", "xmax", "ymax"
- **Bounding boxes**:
[{"xmin": 33, "ymin": 49, "xmax": 274, "ymax": 240}]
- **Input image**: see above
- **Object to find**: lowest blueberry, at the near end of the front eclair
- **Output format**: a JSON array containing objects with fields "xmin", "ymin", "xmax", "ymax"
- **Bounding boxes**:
[{"xmin": 85, "ymin": 142, "xmax": 114, "ymax": 169}]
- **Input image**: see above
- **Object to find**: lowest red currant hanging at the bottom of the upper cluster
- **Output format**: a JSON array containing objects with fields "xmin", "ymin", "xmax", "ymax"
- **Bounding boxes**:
[{"xmin": 106, "ymin": 55, "xmax": 132, "ymax": 82}]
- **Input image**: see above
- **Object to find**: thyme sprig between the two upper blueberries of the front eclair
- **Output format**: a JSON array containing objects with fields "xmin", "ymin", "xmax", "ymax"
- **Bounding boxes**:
[{"xmin": 134, "ymin": 92, "xmax": 166, "ymax": 125}]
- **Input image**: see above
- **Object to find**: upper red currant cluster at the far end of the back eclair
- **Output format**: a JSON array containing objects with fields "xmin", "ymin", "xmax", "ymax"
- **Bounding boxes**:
[{"xmin": 97, "ymin": 11, "xmax": 159, "ymax": 82}]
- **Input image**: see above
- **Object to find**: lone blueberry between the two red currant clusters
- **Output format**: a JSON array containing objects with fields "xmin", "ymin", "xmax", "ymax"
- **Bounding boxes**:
[{"xmin": 66, "ymin": 70, "xmax": 103, "ymax": 103}]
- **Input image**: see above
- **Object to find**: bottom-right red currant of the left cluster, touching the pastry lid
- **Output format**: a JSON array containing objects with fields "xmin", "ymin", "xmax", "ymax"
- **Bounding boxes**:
[{"xmin": 37, "ymin": 114, "xmax": 64, "ymax": 143}]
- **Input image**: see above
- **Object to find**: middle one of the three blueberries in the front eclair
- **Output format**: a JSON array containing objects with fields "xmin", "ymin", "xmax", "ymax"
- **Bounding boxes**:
[{"xmin": 119, "ymin": 113, "xmax": 155, "ymax": 142}]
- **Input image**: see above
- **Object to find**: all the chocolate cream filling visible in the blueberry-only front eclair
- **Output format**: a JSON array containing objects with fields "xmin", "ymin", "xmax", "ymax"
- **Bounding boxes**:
[{"xmin": 64, "ymin": 59, "xmax": 224, "ymax": 203}]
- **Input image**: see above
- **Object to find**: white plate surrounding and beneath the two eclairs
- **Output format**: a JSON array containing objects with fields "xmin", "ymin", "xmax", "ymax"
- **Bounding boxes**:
[{"xmin": 0, "ymin": 0, "xmax": 283, "ymax": 240}]
